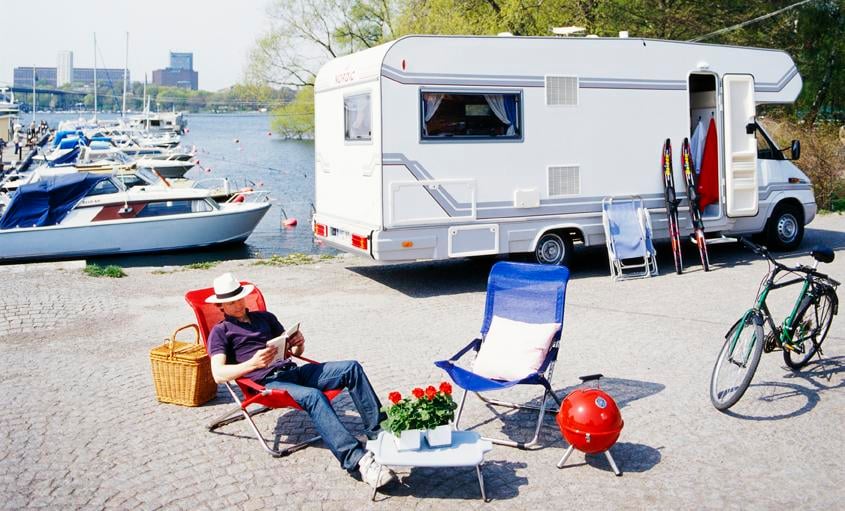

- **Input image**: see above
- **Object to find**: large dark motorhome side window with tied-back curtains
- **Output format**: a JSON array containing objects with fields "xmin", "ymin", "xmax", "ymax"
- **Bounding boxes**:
[{"xmin": 420, "ymin": 91, "xmax": 522, "ymax": 140}]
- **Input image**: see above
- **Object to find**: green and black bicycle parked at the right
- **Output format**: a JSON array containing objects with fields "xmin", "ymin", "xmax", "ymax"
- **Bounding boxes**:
[{"xmin": 710, "ymin": 238, "xmax": 840, "ymax": 411}]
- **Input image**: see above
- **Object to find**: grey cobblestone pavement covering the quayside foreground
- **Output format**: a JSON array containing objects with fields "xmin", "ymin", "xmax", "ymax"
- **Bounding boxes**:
[{"xmin": 0, "ymin": 216, "xmax": 845, "ymax": 510}]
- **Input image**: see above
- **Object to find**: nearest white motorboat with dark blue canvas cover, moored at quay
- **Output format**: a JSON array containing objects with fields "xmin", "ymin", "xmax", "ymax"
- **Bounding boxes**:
[{"xmin": 0, "ymin": 173, "xmax": 270, "ymax": 261}]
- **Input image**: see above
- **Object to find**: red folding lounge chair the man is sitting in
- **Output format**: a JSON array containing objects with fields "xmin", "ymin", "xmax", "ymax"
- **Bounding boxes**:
[{"xmin": 185, "ymin": 282, "xmax": 343, "ymax": 457}]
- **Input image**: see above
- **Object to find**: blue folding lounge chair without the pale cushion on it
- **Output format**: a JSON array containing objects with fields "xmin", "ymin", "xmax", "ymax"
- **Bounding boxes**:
[{"xmin": 434, "ymin": 261, "xmax": 569, "ymax": 449}]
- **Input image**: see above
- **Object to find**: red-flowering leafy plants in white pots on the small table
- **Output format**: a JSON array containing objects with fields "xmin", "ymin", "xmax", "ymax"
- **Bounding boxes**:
[{"xmin": 381, "ymin": 382, "xmax": 458, "ymax": 435}]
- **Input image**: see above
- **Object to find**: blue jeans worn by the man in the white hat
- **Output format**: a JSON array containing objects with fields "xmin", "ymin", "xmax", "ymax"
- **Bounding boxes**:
[{"xmin": 261, "ymin": 360, "xmax": 384, "ymax": 470}]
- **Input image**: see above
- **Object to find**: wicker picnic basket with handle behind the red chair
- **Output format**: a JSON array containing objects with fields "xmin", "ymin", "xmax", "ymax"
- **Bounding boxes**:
[{"xmin": 150, "ymin": 324, "xmax": 217, "ymax": 406}]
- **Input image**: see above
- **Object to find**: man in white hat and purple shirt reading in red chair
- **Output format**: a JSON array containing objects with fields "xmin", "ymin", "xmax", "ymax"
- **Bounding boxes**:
[{"xmin": 206, "ymin": 273, "xmax": 396, "ymax": 488}]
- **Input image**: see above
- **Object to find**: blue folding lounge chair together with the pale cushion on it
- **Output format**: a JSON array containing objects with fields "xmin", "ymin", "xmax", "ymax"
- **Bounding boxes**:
[{"xmin": 434, "ymin": 262, "xmax": 569, "ymax": 449}]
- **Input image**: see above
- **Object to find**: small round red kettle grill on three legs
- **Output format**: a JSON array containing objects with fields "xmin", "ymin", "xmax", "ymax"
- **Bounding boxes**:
[{"xmin": 557, "ymin": 374, "xmax": 624, "ymax": 476}]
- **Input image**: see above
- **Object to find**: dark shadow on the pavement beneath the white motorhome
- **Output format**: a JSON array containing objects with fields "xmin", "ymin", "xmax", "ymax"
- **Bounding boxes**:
[{"xmin": 347, "ymin": 228, "xmax": 845, "ymax": 298}]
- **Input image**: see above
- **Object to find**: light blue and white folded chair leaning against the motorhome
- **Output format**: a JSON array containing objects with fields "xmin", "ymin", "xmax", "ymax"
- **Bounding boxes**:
[{"xmin": 601, "ymin": 196, "xmax": 657, "ymax": 280}]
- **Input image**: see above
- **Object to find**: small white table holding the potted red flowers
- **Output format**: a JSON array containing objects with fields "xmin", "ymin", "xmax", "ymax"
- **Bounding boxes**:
[{"xmin": 367, "ymin": 431, "xmax": 493, "ymax": 502}]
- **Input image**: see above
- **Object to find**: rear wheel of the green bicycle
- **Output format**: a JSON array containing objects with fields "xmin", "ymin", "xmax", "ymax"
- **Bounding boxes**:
[{"xmin": 783, "ymin": 291, "xmax": 836, "ymax": 370}]
